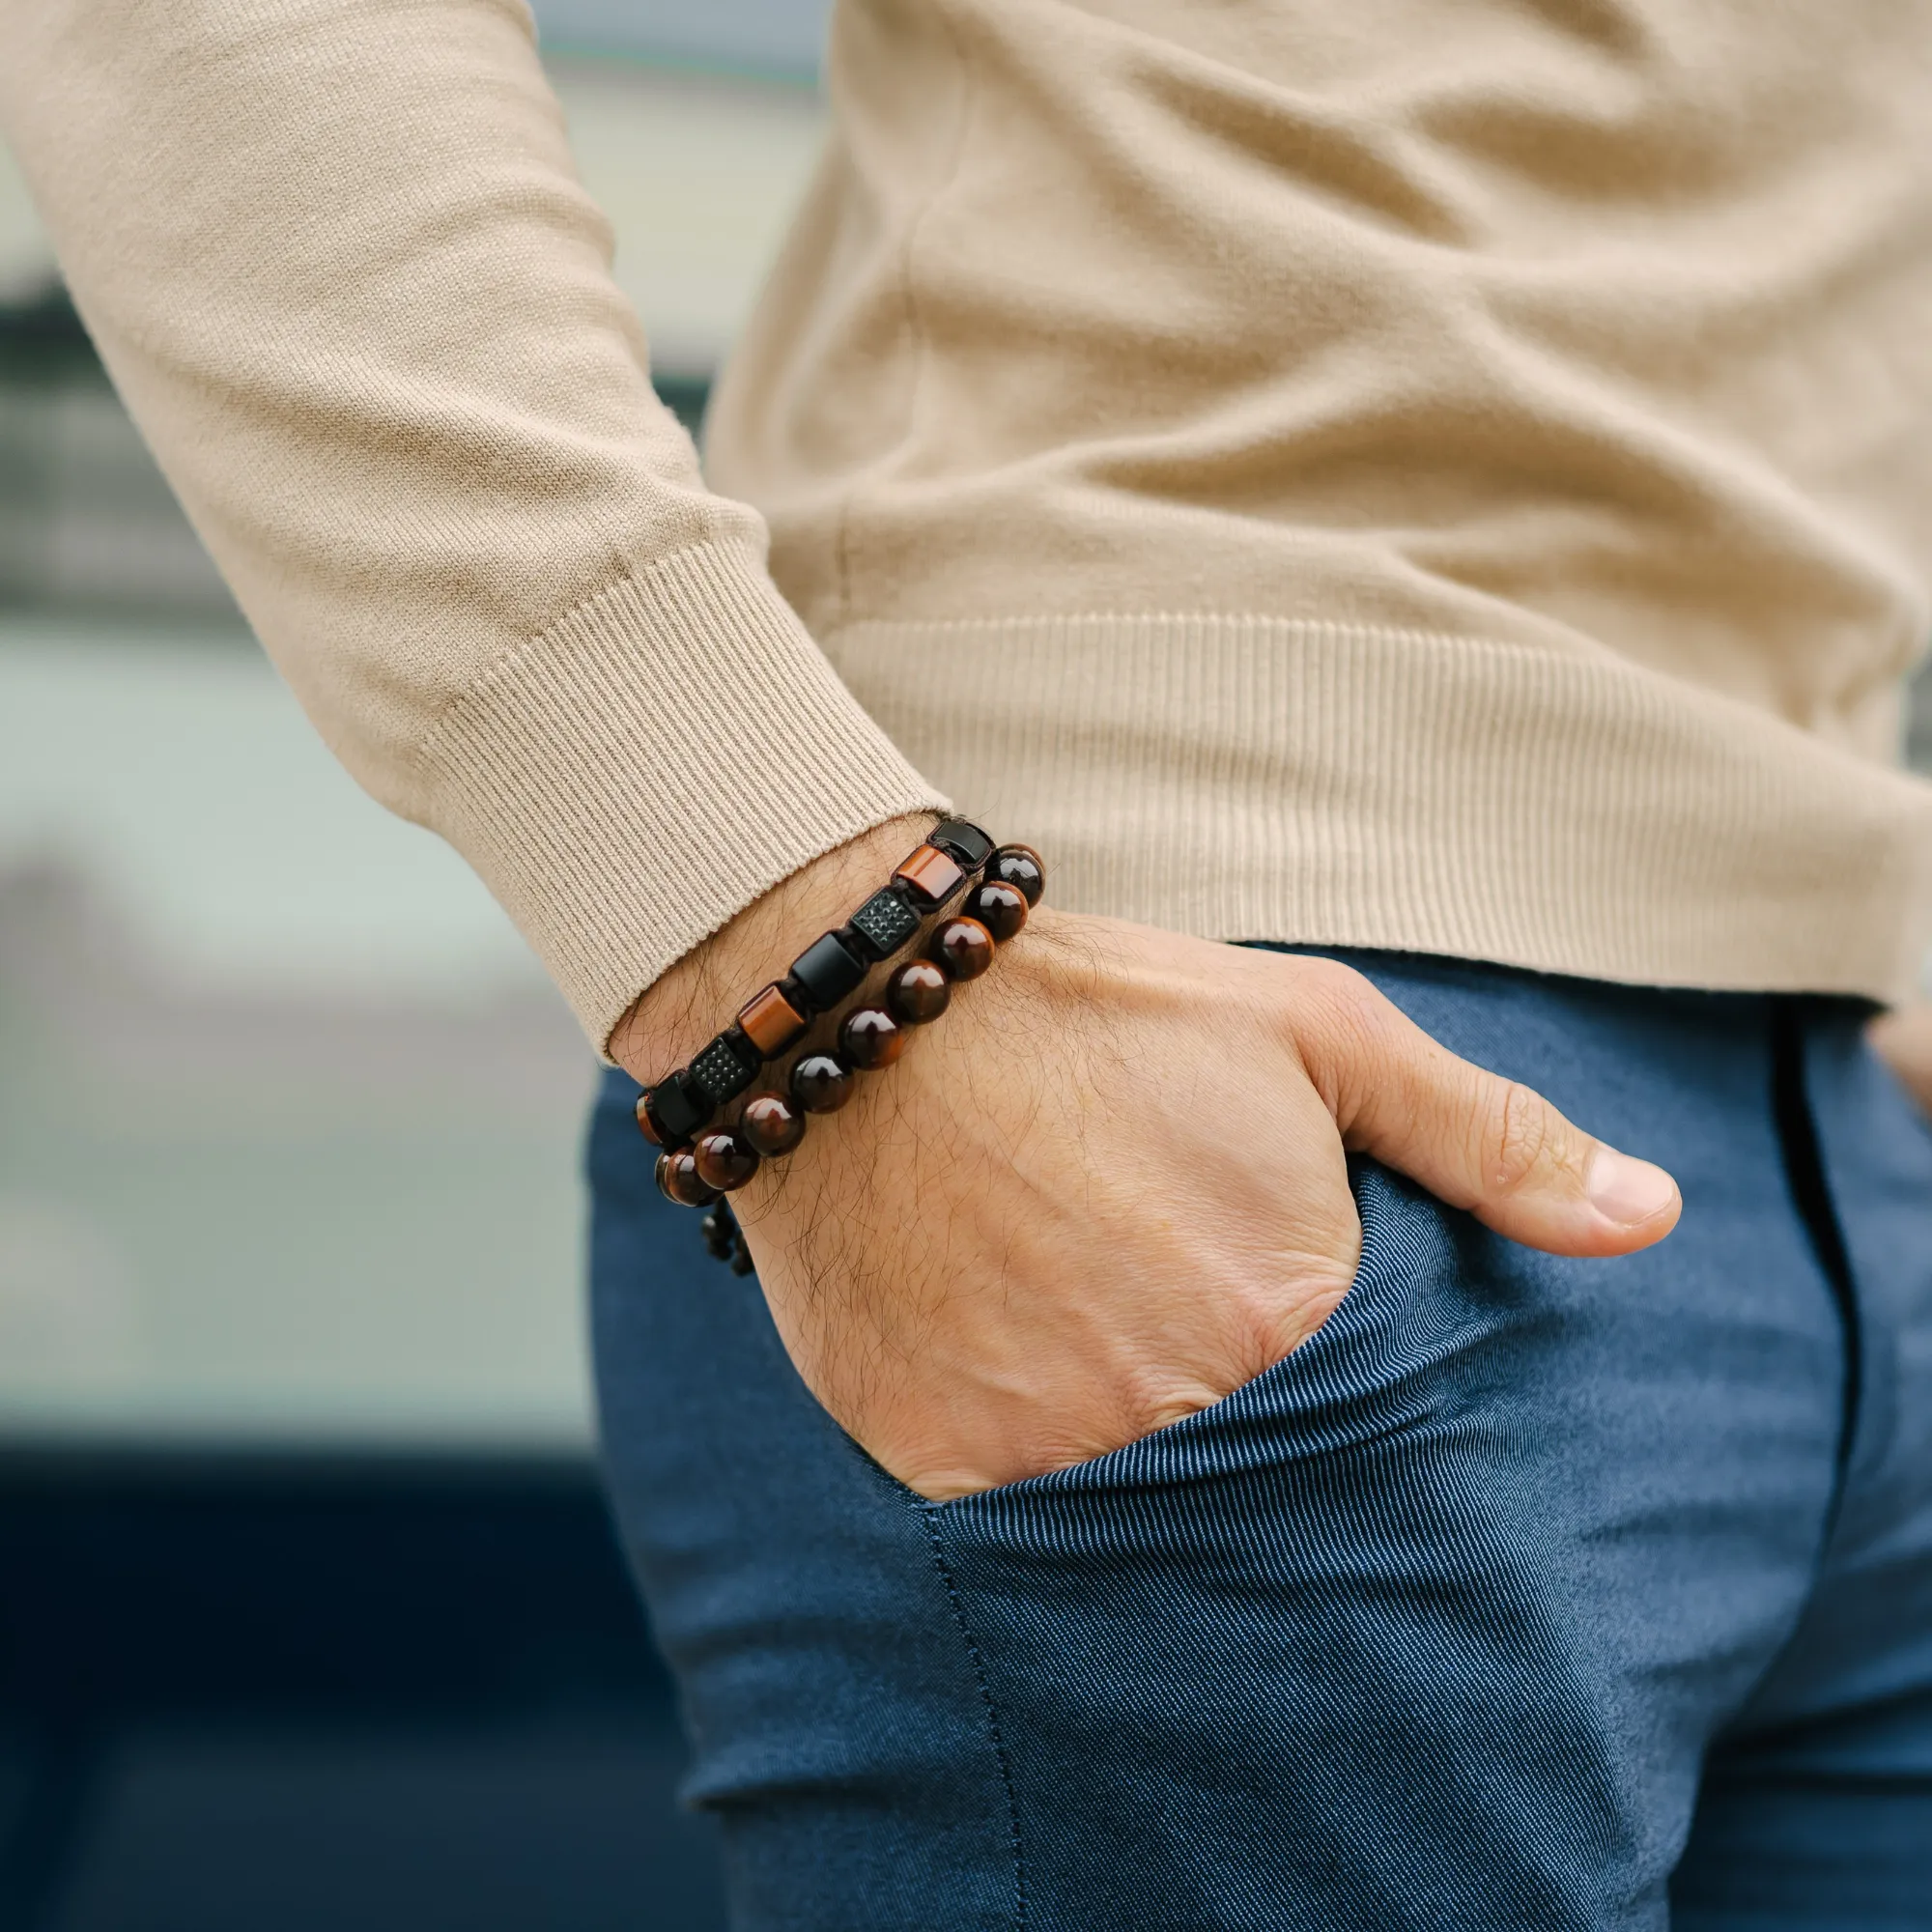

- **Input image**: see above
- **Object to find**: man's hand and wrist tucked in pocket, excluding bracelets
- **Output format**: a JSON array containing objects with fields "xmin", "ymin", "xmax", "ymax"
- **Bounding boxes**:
[{"xmin": 612, "ymin": 821, "xmax": 1681, "ymax": 1497}]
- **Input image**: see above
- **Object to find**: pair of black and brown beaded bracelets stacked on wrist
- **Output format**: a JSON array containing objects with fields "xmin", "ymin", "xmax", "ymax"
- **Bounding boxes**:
[{"xmin": 638, "ymin": 819, "xmax": 1047, "ymax": 1273}]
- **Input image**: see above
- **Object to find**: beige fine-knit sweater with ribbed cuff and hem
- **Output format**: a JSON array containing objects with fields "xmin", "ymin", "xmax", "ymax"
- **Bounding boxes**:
[{"xmin": 0, "ymin": 0, "xmax": 1932, "ymax": 1041}]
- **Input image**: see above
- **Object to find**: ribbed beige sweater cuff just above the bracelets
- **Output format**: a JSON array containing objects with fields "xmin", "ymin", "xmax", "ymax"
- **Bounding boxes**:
[{"xmin": 417, "ymin": 545, "xmax": 947, "ymax": 1051}]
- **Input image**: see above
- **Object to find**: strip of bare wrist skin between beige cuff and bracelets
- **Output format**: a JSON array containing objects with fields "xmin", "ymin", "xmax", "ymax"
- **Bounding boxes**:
[{"xmin": 609, "ymin": 811, "xmax": 933, "ymax": 1086}]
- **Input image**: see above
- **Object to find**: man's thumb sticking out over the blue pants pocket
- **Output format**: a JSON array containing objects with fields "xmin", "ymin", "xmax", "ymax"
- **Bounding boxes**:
[{"xmin": 1294, "ymin": 968, "xmax": 1683, "ymax": 1256}]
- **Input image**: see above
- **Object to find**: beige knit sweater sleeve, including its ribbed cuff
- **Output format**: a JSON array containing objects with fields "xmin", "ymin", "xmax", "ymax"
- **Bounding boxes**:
[{"xmin": 0, "ymin": 0, "xmax": 943, "ymax": 1045}]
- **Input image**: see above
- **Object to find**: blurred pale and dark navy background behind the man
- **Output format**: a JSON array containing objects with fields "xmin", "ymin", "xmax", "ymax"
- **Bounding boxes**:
[{"xmin": 0, "ymin": 0, "xmax": 823, "ymax": 1932}]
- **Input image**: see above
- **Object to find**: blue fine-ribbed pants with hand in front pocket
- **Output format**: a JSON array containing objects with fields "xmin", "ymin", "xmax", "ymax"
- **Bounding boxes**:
[{"xmin": 589, "ymin": 954, "xmax": 1932, "ymax": 1932}]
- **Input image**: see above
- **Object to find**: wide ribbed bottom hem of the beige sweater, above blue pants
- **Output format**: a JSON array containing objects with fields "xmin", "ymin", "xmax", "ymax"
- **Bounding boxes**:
[{"xmin": 825, "ymin": 614, "xmax": 1932, "ymax": 1001}]
